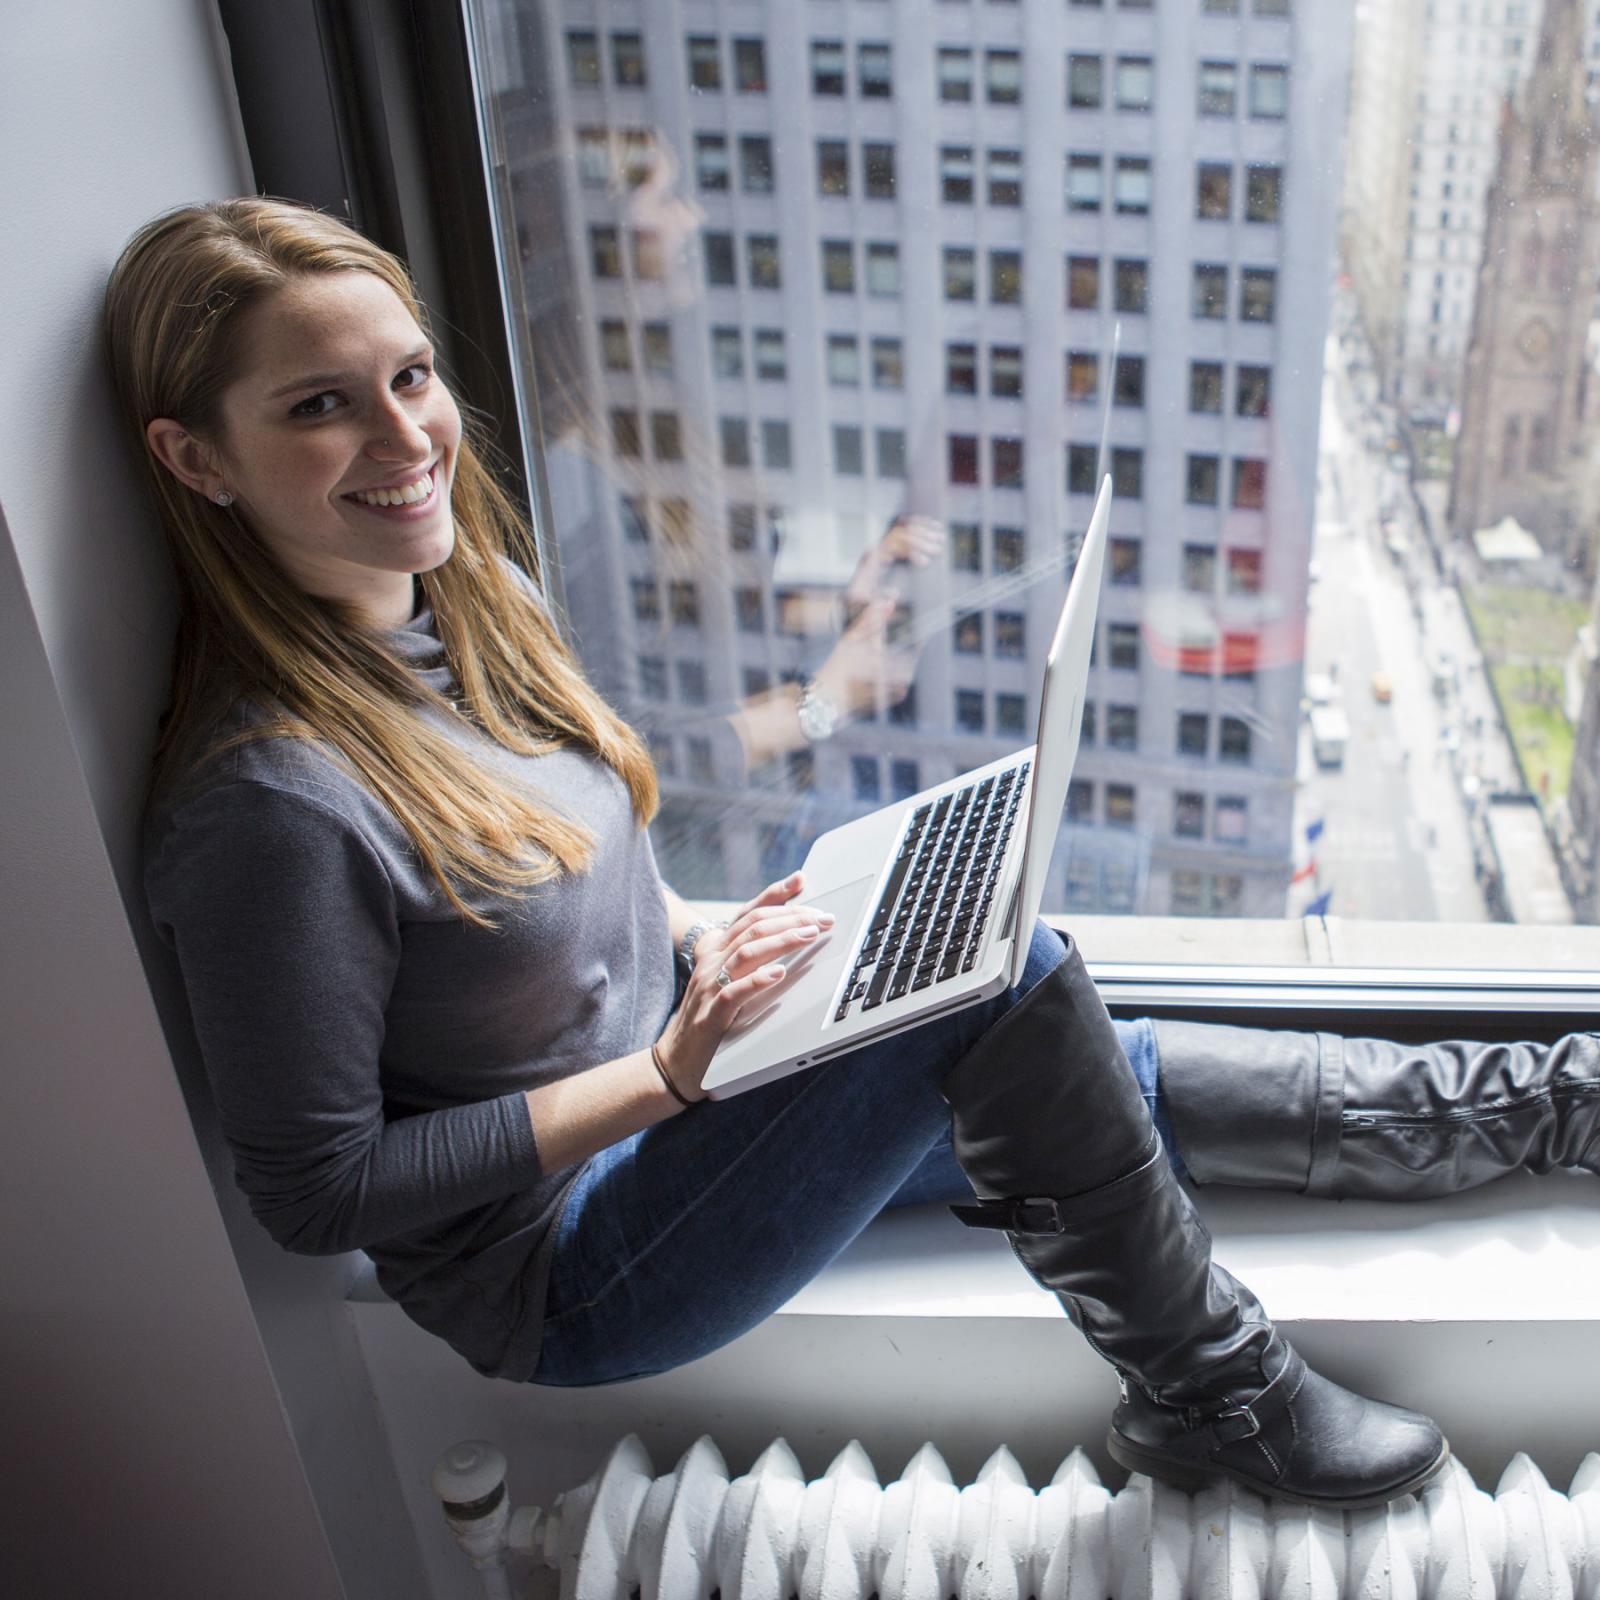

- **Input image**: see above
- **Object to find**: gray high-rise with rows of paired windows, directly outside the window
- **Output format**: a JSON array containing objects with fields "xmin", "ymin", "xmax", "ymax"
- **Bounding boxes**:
[{"xmin": 486, "ymin": 0, "xmax": 1350, "ymax": 915}]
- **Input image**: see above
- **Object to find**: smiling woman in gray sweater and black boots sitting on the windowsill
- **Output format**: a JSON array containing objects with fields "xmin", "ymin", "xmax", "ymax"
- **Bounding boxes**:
[{"xmin": 107, "ymin": 200, "xmax": 1592, "ymax": 1507}]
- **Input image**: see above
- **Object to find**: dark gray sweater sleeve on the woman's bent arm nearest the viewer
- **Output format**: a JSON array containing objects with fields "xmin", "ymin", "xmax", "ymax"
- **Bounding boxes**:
[{"xmin": 146, "ymin": 781, "xmax": 539, "ymax": 1254}]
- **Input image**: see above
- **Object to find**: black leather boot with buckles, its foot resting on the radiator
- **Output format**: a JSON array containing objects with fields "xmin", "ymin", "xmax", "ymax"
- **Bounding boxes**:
[{"xmin": 944, "ymin": 944, "xmax": 1450, "ymax": 1510}]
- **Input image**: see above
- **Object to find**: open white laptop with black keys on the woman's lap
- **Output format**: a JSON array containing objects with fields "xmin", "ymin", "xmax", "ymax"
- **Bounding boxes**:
[{"xmin": 701, "ymin": 477, "xmax": 1110, "ymax": 1099}]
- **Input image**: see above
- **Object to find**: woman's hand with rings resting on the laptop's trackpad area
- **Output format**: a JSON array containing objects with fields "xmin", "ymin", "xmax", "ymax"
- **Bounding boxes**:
[{"xmin": 656, "ymin": 872, "xmax": 834, "ymax": 1101}]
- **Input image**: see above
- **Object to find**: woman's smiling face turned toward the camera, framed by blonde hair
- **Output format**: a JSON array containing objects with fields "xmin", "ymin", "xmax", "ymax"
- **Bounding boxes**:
[{"xmin": 203, "ymin": 270, "xmax": 461, "ymax": 627}]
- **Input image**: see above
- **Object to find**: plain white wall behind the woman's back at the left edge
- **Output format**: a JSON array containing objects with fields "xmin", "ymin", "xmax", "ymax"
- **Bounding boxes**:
[{"xmin": 0, "ymin": 0, "xmax": 426, "ymax": 1600}]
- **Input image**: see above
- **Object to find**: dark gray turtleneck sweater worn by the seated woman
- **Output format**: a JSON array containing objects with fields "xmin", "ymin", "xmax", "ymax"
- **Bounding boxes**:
[{"xmin": 146, "ymin": 574, "xmax": 674, "ymax": 1379}]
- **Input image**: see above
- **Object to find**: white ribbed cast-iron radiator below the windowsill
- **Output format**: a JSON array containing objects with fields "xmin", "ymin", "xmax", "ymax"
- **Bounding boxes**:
[{"xmin": 434, "ymin": 1437, "xmax": 1600, "ymax": 1600}]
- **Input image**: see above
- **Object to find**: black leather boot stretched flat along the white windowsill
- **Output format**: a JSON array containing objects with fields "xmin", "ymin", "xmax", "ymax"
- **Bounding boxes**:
[{"xmin": 1152, "ymin": 1022, "xmax": 1600, "ymax": 1200}]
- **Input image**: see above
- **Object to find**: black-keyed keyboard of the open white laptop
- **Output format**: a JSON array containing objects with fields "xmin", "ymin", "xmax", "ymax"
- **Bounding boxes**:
[{"xmin": 834, "ymin": 762, "xmax": 1034, "ymax": 1022}]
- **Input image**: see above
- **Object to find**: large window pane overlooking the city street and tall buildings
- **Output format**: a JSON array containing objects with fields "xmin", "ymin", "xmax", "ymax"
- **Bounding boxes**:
[{"xmin": 467, "ymin": 0, "xmax": 1600, "ymax": 960}]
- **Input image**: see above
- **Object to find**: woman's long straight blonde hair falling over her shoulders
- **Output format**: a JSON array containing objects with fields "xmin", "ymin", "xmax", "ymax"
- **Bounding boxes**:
[{"xmin": 106, "ymin": 198, "xmax": 658, "ymax": 926}]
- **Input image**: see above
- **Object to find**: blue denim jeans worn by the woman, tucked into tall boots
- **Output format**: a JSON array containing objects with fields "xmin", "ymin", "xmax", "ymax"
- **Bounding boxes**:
[{"xmin": 533, "ymin": 926, "xmax": 1176, "ymax": 1387}]
